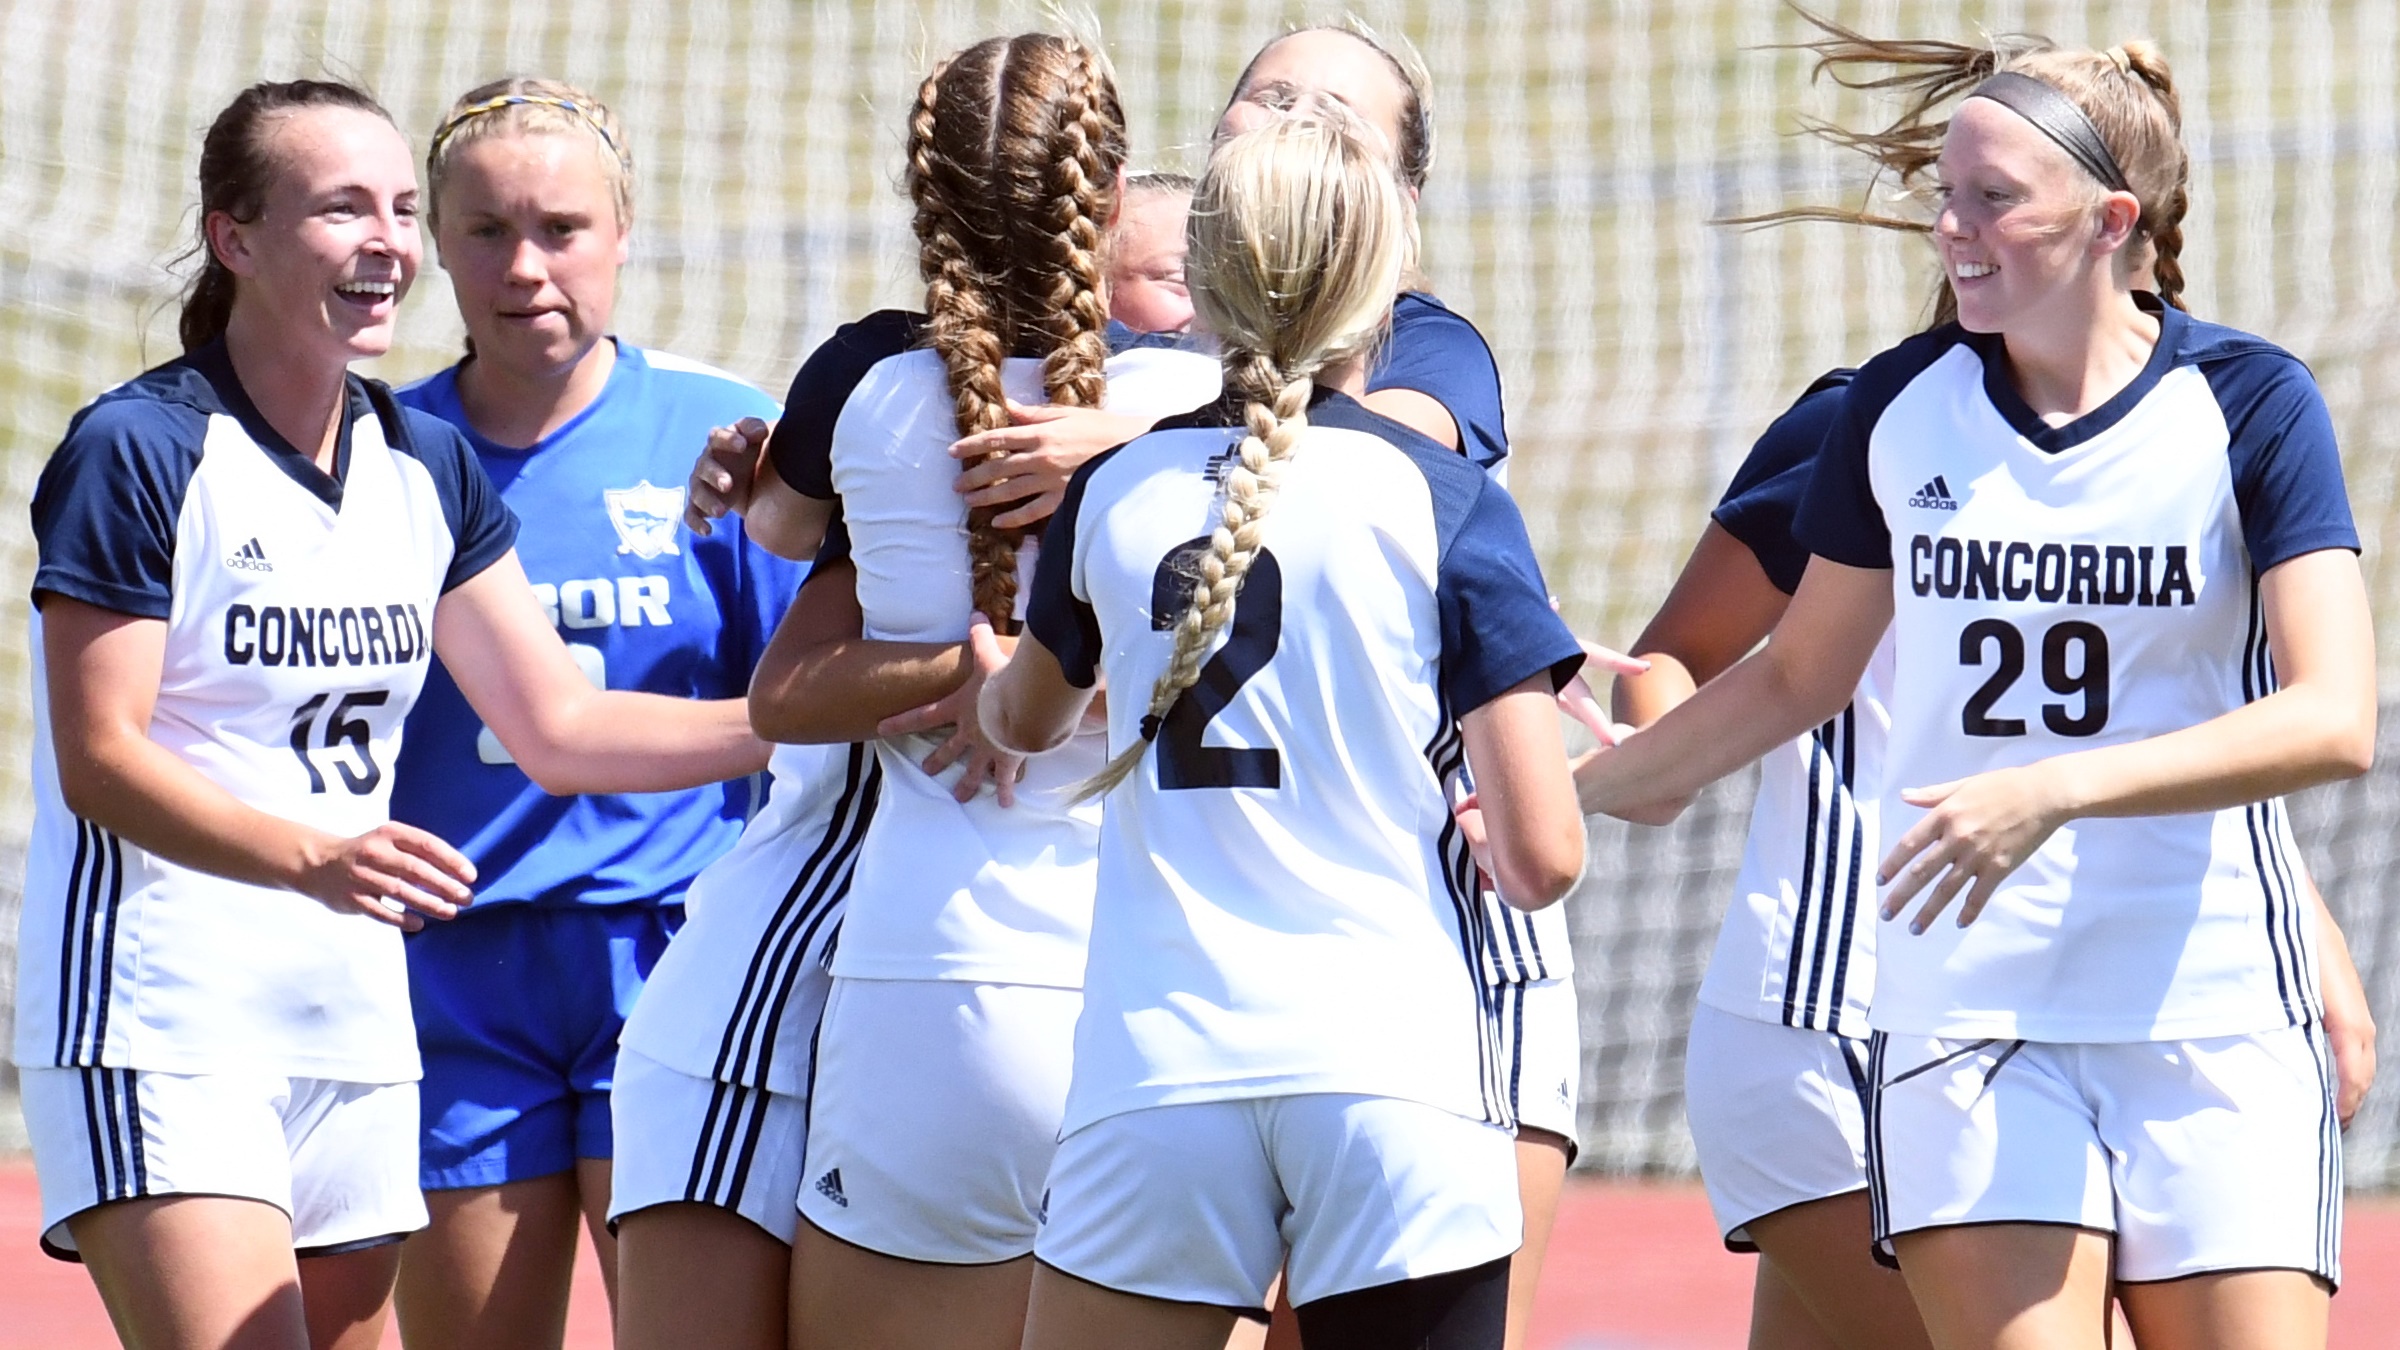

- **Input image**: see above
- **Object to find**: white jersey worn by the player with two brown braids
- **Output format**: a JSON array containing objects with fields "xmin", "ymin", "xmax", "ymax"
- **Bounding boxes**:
[{"xmin": 773, "ymin": 312, "xmax": 1219, "ymax": 987}]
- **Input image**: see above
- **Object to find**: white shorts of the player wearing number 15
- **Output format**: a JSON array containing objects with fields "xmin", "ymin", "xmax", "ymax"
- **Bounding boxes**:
[{"xmin": 19, "ymin": 1069, "xmax": 425, "ymax": 1261}]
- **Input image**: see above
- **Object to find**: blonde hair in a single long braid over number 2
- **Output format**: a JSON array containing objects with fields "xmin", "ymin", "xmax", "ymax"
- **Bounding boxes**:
[{"xmin": 1080, "ymin": 101, "xmax": 1416, "ymax": 798}]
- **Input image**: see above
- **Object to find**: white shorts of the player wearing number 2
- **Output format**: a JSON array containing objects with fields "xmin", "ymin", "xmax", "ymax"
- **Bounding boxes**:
[{"xmin": 1034, "ymin": 1093, "xmax": 1524, "ymax": 1312}]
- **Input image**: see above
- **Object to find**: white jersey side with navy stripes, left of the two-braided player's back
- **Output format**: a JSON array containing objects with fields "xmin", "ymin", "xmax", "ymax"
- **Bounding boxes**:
[{"xmin": 619, "ymin": 745, "xmax": 883, "ymax": 1095}]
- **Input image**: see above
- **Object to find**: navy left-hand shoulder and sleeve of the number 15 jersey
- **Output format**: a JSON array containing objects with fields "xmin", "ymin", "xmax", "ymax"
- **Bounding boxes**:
[{"xmin": 34, "ymin": 360, "xmax": 223, "ymax": 620}]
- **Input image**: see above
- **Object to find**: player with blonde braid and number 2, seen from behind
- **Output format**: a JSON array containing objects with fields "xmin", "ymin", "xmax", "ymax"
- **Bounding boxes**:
[{"xmin": 984, "ymin": 106, "xmax": 1584, "ymax": 1350}]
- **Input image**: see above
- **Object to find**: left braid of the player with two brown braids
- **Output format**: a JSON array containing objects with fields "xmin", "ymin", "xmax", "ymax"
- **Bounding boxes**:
[{"xmin": 907, "ymin": 38, "xmax": 1018, "ymax": 632}]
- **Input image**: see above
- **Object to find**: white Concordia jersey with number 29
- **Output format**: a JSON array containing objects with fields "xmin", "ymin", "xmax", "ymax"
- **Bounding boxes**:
[{"xmin": 1798, "ymin": 300, "xmax": 2357, "ymax": 1040}]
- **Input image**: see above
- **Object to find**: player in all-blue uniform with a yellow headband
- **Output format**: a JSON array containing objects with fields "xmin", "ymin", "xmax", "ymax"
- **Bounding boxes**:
[{"xmin": 391, "ymin": 77, "xmax": 802, "ymax": 1350}]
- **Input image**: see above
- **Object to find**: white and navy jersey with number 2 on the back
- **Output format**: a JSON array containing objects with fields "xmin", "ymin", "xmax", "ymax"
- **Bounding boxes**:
[{"xmin": 1027, "ymin": 394, "xmax": 1582, "ymax": 1131}]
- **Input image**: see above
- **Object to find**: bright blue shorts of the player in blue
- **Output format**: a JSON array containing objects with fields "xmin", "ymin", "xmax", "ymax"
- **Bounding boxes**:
[{"xmin": 408, "ymin": 903, "xmax": 684, "ymax": 1191}]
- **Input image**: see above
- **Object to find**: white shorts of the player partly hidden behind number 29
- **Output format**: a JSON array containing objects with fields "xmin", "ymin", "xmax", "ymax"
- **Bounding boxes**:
[{"xmin": 1682, "ymin": 1004, "xmax": 1872, "ymax": 1252}]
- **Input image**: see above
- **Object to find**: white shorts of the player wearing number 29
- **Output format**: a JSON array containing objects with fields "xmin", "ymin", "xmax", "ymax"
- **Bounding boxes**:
[{"xmin": 1867, "ymin": 1026, "xmax": 2342, "ymax": 1283}]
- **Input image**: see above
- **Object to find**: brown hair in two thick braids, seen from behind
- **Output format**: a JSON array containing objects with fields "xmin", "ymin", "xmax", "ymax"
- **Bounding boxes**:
[{"xmin": 907, "ymin": 34, "xmax": 1126, "ymax": 632}]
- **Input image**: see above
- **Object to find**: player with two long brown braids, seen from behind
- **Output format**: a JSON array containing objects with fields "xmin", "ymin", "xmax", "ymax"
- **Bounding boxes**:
[{"xmin": 672, "ymin": 34, "xmax": 1217, "ymax": 1345}]
